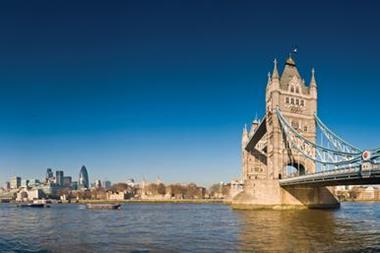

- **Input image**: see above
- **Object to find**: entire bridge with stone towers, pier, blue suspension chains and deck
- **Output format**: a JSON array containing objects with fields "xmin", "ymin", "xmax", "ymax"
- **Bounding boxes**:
[{"xmin": 232, "ymin": 56, "xmax": 380, "ymax": 208}]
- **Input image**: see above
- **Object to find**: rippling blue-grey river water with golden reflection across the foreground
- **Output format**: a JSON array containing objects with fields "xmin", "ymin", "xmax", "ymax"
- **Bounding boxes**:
[{"xmin": 0, "ymin": 203, "xmax": 380, "ymax": 252}]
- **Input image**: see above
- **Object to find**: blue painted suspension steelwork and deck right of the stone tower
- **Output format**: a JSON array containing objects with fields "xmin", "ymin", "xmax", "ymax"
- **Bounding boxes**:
[{"xmin": 275, "ymin": 108, "xmax": 380, "ymax": 186}]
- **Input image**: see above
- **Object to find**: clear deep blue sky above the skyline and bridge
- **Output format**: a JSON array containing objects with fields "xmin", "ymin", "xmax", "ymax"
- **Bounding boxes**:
[{"xmin": 0, "ymin": 0, "xmax": 380, "ymax": 184}]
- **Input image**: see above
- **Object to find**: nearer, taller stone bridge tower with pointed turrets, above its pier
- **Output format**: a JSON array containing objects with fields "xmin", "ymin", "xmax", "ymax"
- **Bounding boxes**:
[{"xmin": 266, "ymin": 56, "xmax": 317, "ymax": 182}]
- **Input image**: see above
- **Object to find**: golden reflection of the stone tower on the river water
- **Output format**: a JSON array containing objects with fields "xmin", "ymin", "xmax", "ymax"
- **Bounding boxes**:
[{"xmin": 239, "ymin": 210, "xmax": 336, "ymax": 252}]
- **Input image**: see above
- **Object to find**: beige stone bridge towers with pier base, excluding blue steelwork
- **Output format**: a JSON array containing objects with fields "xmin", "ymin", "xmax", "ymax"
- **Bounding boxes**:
[{"xmin": 232, "ymin": 55, "xmax": 339, "ymax": 208}]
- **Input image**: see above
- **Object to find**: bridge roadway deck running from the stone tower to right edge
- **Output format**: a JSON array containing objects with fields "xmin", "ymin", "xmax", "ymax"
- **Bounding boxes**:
[{"xmin": 279, "ymin": 164, "xmax": 380, "ymax": 187}]
